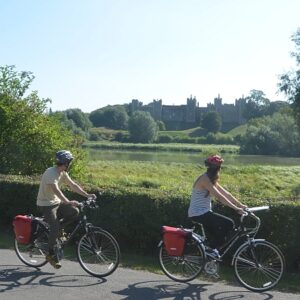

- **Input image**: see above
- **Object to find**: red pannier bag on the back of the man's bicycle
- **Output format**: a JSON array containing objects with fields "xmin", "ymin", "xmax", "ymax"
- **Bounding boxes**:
[{"xmin": 13, "ymin": 215, "xmax": 32, "ymax": 245}]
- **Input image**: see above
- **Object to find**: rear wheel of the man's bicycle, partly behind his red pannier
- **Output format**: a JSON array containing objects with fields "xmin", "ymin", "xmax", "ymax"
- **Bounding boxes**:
[{"xmin": 14, "ymin": 232, "xmax": 48, "ymax": 268}]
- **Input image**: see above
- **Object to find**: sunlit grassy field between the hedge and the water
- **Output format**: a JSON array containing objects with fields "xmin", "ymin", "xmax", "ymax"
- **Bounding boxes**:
[{"xmin": 87, "ymin": 161, "xmax": 300, "ymax": 201}]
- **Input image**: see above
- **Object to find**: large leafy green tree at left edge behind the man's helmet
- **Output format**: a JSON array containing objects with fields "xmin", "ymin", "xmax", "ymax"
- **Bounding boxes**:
[{"xmin": 0, "ymin": 66, "xmax": 81, "ymax": 175}]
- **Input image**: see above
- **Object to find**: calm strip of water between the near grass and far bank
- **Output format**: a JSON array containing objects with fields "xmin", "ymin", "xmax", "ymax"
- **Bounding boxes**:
[{"xmin": 87, "ymin": 149, "xmax": 300, "ymax": 166}]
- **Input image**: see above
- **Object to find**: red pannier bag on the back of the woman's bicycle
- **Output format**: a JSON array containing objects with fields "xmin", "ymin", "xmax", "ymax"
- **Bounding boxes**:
[{"xmin": 162, "ymin": 226, "xmax": 189, "ymax": 256}]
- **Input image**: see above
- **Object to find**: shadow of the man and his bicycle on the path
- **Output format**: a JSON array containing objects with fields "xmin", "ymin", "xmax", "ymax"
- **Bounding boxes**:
[{"xmin": 0, "ymin": 265, "xmax": 106, "ymax": 293}]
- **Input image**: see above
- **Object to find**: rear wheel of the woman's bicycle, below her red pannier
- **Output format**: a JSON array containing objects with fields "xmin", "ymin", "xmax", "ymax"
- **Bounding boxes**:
[{"xmin": 158, "ymin": 237, "xmax": 205, "ymax": 282}]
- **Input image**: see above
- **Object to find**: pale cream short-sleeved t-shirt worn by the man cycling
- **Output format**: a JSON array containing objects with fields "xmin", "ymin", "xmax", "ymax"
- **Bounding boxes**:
[{"xmin": 36, "ymin": 167, "xmax": 71, "ymax": 206}]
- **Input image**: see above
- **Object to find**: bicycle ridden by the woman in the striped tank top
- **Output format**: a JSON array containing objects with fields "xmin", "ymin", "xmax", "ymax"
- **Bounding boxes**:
[{"xmin": 158, "ymin": 206, "xmax": 285, "ymax": 292}]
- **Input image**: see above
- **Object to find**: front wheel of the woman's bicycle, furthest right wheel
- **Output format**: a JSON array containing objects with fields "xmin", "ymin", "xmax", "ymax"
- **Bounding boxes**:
[{"xmin": 233, "ymin": 241, "xmax": 285, "ymax": 292}]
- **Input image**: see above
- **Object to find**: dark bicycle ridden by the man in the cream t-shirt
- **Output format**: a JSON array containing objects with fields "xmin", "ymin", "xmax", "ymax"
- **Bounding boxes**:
[{"xmin": 14, "ymin": 198, "xmax": 120, "ymax": 277}]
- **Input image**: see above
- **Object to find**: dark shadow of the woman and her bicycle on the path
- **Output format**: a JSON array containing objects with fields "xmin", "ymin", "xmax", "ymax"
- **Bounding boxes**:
[{"xmin": 112, "ymin": 281, "xmax": 273, "ymax": 300}]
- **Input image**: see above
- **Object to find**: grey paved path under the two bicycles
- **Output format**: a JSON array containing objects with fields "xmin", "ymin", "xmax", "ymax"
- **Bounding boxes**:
[{"xmin": 0, "ymin": 250, "xmax": 300, "ymax": 300}]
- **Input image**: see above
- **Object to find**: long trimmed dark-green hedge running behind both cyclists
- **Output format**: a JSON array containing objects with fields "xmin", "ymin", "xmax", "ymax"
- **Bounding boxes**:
[{"xmin": 0, "ymin": 176, "xmax": 300, "ymax": 271}]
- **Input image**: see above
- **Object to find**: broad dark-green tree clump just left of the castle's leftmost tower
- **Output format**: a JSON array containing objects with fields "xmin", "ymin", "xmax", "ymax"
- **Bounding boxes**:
[{"xmin": 90, "ymin": 105, "xmax": 128, "ymax": 129}]
